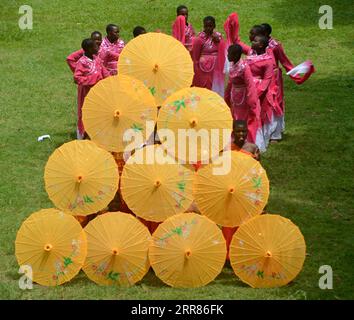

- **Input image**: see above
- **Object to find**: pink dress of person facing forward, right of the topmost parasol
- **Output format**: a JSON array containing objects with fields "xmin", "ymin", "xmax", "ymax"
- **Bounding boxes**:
[{"xmin": 192, "ymin": 32, "xmax": 226, "ymax": 97}]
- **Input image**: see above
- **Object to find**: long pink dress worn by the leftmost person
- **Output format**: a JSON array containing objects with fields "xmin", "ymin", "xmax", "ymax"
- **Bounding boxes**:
[{"xmin": 74, "ymin": 55, "xmax": 110, "ymax": 137}]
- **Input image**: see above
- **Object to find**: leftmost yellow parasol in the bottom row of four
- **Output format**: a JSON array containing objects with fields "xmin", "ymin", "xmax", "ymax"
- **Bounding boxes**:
[{"xmin": 15, "ymin": 209, "xmax": 86, "ymax": 286}]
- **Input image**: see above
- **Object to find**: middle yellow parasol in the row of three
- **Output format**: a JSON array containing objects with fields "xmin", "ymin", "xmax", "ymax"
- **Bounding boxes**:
[{"xmin": 121, "ymin": 145, "xmax": 194, "ymax": 222}]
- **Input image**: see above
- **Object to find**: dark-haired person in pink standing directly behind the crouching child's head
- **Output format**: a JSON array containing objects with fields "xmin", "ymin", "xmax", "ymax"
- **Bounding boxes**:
[{"xmin": 225, "ymin": 44, "xmax": 265, "ymax": 152}]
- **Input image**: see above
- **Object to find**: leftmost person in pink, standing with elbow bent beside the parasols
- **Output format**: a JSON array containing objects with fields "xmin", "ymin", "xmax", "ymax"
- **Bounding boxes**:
[{"xmin": 74, "ymin": 39, "xmax": 110, "ymax": 139}]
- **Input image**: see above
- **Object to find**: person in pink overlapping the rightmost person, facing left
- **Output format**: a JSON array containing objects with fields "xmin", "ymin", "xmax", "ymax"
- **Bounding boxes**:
[{"xmin": 246, "ymin": 35, "xmax": 280, "ymax": 151}]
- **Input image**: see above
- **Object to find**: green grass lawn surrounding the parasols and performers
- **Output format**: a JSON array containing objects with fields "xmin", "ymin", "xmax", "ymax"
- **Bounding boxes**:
[{"xmin": 0, "ymin": 0, "xmax": 354, "ymax": 299}]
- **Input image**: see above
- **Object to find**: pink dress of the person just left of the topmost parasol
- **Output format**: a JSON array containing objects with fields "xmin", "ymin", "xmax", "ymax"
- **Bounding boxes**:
[{"xmin": 98, "ymin": 37, "xmax": 125, "ymax": 76}]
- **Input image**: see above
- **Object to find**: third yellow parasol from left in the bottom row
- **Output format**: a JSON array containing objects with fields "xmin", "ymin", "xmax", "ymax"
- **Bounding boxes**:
[{"xmin": 149, "ymin": 213, "xmax": 226, "ymax": 288}]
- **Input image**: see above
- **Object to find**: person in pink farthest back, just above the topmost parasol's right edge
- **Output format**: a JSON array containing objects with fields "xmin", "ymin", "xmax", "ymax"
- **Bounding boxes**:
[{"xmin": 172, "ymin": 5, "xmax": 195, "ymax": 52}]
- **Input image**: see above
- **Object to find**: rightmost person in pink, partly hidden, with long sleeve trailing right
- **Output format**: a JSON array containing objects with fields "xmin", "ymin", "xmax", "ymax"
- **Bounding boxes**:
[{"xmin": 261, "ymin": 23, "xmax": 313, "ymax": 142}]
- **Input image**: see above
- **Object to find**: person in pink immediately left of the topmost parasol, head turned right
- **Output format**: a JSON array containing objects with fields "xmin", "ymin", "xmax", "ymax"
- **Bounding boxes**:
[{"xmin": 99, "ymin": 24, "xmax": 125, "ymax": 75}]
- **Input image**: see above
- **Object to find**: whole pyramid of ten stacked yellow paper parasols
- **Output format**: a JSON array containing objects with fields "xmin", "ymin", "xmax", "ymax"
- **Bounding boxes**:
[{"xmin": 15, "ymin": 33, "xmax": 306, "ymax": 287}]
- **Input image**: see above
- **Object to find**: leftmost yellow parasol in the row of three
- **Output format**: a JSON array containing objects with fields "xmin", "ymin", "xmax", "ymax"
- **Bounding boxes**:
[{"xmin": 44, "ymin": 140, "xmax": 119, "ymax": 215}]
